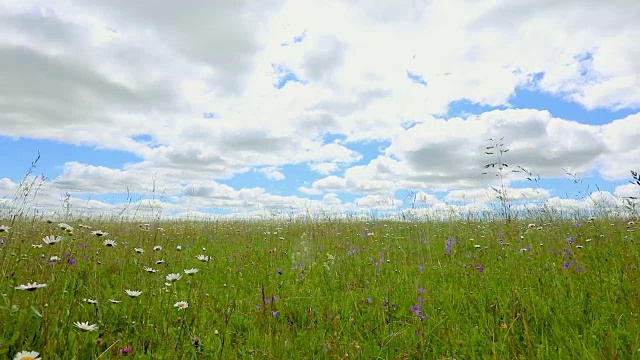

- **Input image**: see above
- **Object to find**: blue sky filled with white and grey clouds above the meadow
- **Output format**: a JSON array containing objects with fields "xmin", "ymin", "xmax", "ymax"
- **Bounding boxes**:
[{"xmin": 0, "ymin": 0, "xmax": 640, "ymax": 216}]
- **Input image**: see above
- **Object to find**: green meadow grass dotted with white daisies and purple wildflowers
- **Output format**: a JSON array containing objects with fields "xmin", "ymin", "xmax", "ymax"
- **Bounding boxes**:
[{"xmin": 0, "ymin": 220, "xmax": 640, "ymax": 359}]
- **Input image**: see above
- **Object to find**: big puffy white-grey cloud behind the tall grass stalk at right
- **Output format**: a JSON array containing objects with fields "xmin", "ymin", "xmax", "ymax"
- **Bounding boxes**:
[{"xmin": 311, "ymin": 109, "xmax": 640, "ymax": 195}]
